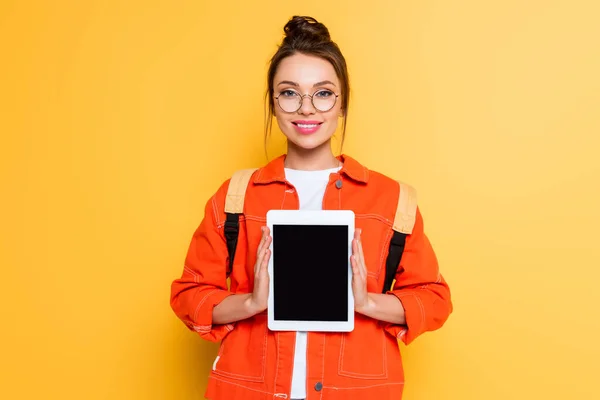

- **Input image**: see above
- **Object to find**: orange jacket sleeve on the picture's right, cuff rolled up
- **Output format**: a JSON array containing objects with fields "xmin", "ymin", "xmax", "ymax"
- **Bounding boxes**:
[{"xmin": 385, "ymin": 208, "xmax": 452, "ymax": 344}]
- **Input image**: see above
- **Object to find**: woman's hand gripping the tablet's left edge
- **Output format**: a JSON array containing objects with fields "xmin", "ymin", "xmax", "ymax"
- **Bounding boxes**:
[{"xmin": 247, "ymin": 226, "xmax": 272, "ymax": 315}]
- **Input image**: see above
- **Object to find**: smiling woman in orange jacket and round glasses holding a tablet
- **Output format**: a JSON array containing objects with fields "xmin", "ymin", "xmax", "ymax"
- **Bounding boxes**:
[{"xmin": 171, "ymin": 17, "xmax": 452, "ymax": 400}]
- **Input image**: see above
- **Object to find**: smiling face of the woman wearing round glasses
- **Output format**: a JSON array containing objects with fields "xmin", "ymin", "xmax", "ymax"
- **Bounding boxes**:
[{"xmin": 273, "ymin": 54, "xmax": 342, "ymax": 150}]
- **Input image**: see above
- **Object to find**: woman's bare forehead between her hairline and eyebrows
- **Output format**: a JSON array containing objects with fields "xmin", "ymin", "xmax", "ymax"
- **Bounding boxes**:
[{"xmin": 273, "ymin": 54, "xmax": 340, "ymax": 87}]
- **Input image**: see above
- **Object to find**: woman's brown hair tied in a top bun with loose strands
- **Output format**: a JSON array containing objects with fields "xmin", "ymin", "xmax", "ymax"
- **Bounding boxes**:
[{"xmin": 264, "ymin": 16, "xmax": 350, "ymax": 156}]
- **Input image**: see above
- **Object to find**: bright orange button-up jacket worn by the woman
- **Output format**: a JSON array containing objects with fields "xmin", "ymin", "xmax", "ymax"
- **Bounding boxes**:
[{"xmin": 171, "ymin": 156, "xmax": 452, "ymax": 400}]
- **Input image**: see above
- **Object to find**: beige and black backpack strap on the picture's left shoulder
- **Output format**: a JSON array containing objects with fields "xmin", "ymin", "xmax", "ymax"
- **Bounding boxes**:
[{"xmin": 224, "ymin": 168, "xmax": 256, "ymax": 276}]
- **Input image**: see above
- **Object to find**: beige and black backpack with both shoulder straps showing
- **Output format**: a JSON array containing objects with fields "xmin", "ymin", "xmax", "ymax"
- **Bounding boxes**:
[{"xmin": 225, "ymin": 168, "xmax": 417, "ymax": 293}]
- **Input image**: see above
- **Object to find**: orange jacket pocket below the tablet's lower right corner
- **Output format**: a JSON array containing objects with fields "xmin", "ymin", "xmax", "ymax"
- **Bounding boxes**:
[{"xmin": 338, "ymin": 315, "xmax": 388, "ymax": 379}]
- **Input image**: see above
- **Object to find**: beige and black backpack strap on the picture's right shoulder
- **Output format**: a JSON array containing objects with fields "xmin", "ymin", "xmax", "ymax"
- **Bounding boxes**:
[{"xmin": 383, "ymin": 182, "xmax": 417, "ymax": 293}]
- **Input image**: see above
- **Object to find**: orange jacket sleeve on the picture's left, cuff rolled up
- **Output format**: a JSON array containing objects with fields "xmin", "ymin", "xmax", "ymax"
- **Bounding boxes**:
[{"xmin": 171, "ymin": 186, "xmax": 234, "ymax": 342}]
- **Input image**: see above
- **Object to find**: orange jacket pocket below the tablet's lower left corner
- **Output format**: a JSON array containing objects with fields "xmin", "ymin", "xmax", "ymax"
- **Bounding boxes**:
[{"xmin": 213, "ymin": 315, "xmax": 267, "ymax": 382}]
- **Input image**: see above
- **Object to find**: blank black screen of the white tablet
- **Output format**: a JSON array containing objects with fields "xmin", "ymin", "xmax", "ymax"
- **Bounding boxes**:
[{"xmin": 273, "ymin": 225, "xmax": 349, "ymax": 321}]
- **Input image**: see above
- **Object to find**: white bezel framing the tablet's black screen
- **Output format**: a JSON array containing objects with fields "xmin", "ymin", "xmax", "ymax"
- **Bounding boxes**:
[{"xmin": 267, "ymin": 210, "xmax": 355, "ymax": 332}]
